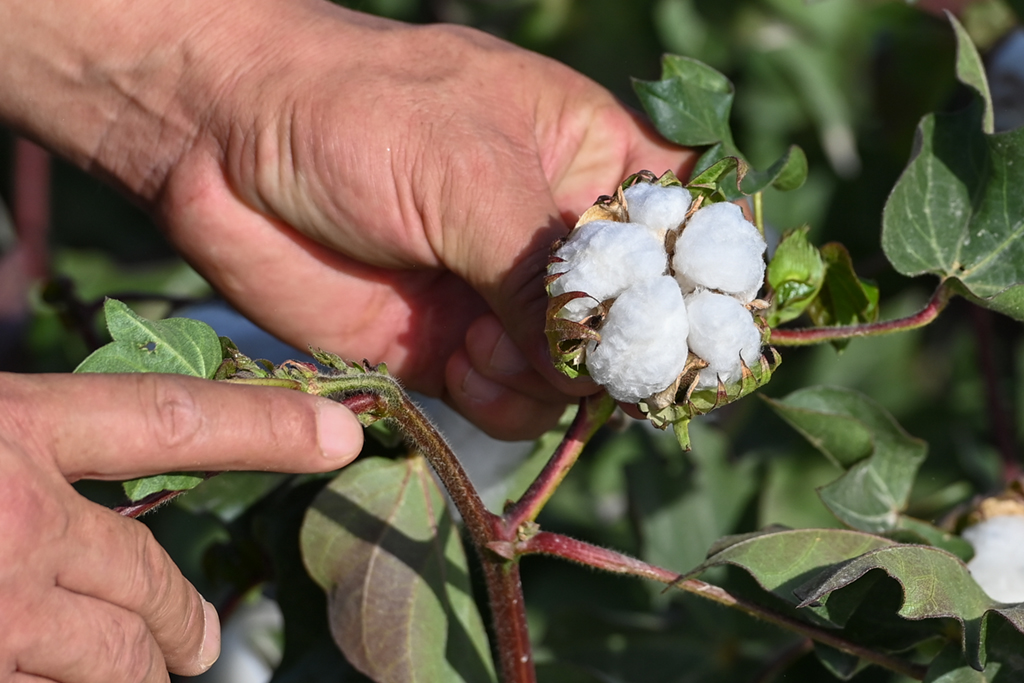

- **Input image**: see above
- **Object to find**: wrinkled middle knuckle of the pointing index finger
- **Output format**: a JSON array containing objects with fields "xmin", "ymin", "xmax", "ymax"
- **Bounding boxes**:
[{"xmin": 138, "ymin": 375, "xmax": 204, "ymax": 449}]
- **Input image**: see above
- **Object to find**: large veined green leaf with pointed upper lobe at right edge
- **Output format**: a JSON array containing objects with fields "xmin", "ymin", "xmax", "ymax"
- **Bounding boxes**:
[{"xmin": 882, "ymin": 18, "xmax": 1024, "ymax": 319}]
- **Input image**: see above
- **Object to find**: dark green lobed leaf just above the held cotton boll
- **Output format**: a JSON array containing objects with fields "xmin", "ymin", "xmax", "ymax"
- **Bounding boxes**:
[{"xmin": 633, "ymin": 54, "xmax": 735, "ymax": 154}]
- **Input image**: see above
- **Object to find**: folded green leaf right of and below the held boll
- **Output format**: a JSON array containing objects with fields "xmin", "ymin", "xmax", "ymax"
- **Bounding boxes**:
[{"xmin": 766, "ymin": 387, "xmax": 928, "ymax": 531}]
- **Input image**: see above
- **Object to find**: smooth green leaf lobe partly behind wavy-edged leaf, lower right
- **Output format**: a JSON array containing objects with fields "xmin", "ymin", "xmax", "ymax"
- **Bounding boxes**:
[{"xmin": 682, "ymin": 528, "xmax": 894, "ymax": 626}]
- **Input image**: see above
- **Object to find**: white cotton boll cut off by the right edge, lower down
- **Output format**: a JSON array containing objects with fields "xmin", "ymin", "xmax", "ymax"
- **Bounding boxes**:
[{"xmin": 964, "ymin": 515, "xmax": 1024, "ymax": 602}]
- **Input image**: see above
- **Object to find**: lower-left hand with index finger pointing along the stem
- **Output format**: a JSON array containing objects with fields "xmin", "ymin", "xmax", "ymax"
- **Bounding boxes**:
[{"xmin": 0, "ymin": 374, "xmax": 362, "ymax": 683}]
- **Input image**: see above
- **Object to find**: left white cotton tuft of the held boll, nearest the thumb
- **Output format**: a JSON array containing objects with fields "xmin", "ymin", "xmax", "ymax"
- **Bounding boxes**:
[{"xmin": 549, "ymin": 220, "xmax": 669, "ymax": 322}]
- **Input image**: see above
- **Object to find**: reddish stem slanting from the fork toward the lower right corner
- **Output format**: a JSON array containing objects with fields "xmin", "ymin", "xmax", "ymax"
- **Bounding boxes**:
[{"xmin": 515, "ymin": 531, "xmax": 926, "ymax": 681}]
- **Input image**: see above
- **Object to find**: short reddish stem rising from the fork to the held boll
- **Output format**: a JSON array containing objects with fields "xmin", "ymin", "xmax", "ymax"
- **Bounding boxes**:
[{"xmin": 505, "ymin": 391, "xmax": 615, "ymax": 530}]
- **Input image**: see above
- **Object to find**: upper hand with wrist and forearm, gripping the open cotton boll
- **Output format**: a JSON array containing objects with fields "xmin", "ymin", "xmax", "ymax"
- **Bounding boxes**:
[{"xmin": 0, "ymin": 0, "xmax": 692, "ymax": 438}]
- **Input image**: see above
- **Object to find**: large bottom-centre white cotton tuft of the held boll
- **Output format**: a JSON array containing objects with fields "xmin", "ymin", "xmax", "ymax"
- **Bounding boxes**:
[{"xmin": 587, "ymin": 275, "xmax": 689, "ymax": 403}]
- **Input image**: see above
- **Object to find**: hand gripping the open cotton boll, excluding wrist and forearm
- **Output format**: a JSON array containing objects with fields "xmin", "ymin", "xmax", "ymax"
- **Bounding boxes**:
[{"xmin": 160, "ymin": 3, "xmax": 686, "ymax": 438}]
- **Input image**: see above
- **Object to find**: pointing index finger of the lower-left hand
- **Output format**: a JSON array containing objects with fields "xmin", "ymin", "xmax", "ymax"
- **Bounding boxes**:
[{"xmin": 0, "ymin": 374, "xmax": 362, "ymax": 480}]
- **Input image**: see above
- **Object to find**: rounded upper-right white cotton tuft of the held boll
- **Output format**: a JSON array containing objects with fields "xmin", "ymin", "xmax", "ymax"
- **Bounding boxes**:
[{"xmin": 672, "ymin": 202, "xmax": 765, "ymax": 303}]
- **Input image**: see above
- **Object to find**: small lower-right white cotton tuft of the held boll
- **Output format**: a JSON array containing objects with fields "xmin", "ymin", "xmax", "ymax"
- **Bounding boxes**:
[{"xmin": 686, "ymin": 291, "xmax": 761, "ymax": 389}]
